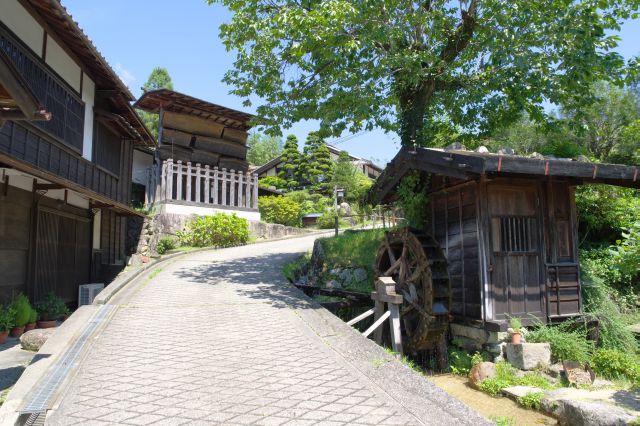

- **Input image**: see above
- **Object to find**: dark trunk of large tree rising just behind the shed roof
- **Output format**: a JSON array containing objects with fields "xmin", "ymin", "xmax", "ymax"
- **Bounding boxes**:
[{"xmin": 398, "ymin": 81, "xmax": 435, "ymax": 146}]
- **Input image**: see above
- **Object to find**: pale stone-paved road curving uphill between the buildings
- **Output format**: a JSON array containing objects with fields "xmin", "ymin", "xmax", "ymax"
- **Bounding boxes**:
[{"xmin": 47, "ymin": 237, "xmax": 483, "ymax": 425}]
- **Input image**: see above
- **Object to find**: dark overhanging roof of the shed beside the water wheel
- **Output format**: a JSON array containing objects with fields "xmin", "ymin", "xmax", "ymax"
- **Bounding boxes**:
[{"xmin": 370, "ymin": 147, "xmax": 640, "ymax": 202}]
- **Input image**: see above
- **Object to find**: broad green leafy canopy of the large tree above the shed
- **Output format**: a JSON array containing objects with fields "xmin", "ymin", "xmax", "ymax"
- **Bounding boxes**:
[{"xmin": 209, "ymin": 0, "xmax": 639, "ymax": 145}]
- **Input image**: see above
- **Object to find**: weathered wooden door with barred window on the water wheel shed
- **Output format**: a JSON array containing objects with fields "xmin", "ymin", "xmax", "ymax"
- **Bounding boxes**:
[{"xmin": 488, "ymin": 185, "xmax": 545, "ymax": 319}]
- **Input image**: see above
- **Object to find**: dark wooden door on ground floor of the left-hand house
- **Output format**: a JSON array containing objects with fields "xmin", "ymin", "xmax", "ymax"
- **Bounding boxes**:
[{"xmin": 32, "ymin": 209, "xmax": 91, "ymax": 302}]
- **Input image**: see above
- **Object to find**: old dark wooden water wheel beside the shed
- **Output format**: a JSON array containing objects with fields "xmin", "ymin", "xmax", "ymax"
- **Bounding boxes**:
[{"xmin": 375, "ymin": 228, "xmax": 451, "ymax": 356}]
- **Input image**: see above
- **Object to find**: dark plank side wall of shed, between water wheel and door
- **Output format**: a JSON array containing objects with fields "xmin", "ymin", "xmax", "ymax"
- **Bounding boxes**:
[{"xmin": 429, "ymin": 182, "xmax": 482, "ymax": 320}]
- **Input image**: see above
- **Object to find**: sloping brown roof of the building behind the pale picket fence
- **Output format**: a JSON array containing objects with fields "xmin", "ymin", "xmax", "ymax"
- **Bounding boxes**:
[{"xmin": 134, "ymin": 89, "xmax": 254, "ymax": 130}]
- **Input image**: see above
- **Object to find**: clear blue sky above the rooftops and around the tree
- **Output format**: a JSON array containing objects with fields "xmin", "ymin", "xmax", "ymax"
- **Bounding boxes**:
[{"xmin": 62, "ymin": 0, "xmax": 640, "ymax": 165}]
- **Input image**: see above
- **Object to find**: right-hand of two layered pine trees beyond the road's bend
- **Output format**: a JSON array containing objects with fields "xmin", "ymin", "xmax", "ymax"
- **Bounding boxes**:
[{"xmin": 301, "ymin": 132, "xmax": 333, "ymax": 194}]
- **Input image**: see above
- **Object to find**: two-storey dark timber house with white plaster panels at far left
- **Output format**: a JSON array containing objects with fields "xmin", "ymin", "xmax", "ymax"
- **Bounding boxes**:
[{"xmin": 0, "ymin": 0, "xmax": 155, "ymax": 302}]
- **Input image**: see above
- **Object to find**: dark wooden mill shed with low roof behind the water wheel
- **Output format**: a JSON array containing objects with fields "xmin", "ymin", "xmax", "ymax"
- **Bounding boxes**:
[{"xmin": 372, "ymin": 148, "xmax": 640, "ymax": 350}]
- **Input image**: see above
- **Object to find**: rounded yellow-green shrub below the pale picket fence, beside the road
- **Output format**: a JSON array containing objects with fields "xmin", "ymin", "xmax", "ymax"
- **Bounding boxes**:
[{"xmin": 177, "ymin": 213, "xmax": 249, "ymax": 247}]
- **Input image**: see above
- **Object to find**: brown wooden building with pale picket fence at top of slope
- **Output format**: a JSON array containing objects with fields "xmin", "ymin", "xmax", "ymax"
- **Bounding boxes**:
[{"xmin": 134, "ymin": 89, "xmax": 260, "ymax": 220}]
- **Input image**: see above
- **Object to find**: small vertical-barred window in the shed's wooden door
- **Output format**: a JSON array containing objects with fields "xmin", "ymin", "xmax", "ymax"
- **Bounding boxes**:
[{"xmin": 493, "ymin": 216, "xmax": 537, "ymax": 253}]
